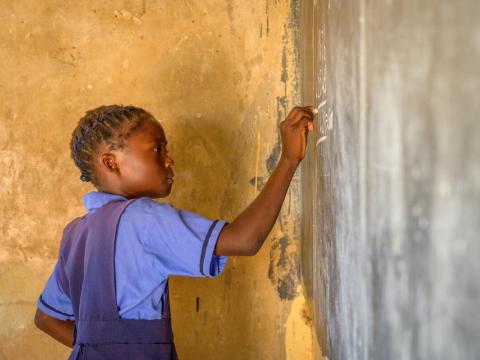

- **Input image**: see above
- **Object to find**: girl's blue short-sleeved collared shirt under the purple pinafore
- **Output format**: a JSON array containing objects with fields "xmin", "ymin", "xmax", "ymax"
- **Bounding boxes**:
[{"xmin": 37, "ymin": 192, "xmax": 227, "ymax": 320}]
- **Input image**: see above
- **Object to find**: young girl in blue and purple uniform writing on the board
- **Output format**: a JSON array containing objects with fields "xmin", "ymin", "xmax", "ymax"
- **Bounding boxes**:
[{"xmin": 35, "ymin": 105, "xmax": 314, "ymax": 360}]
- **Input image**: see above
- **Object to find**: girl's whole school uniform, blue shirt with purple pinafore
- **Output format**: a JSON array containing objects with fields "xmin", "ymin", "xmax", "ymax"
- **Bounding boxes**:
[{"xmin": 37, "ymin": 192, "xmax": 227, "ymax": 360}]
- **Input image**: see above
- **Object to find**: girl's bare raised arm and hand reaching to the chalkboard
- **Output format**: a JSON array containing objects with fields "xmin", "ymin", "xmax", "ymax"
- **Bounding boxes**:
[{"xmin": 215, "ymin": 107, "xmax": 314, "ymax": 256}]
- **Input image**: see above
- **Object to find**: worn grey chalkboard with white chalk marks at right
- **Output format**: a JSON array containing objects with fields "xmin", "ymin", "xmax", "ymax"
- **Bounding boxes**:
[{"xmin": 301, "ymin": 0, "xmax": 480, "ymax": 360}]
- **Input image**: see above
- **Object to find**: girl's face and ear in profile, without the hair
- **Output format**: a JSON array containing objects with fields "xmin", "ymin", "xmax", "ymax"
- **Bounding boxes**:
[{"xmin": 95, "ymin": 119, "xmax": 174, "ymax": 198}]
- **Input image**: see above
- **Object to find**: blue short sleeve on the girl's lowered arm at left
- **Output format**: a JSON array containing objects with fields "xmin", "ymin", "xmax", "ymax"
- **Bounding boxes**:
[{"xmin": 37, "ymin": 263, "xmax": 75, "ymax": 320}]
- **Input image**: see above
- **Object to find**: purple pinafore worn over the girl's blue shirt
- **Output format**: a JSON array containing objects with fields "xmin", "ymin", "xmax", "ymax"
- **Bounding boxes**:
[{"xmin": 58, "ymin": 199, "xmax": 178, "ymax": 360}]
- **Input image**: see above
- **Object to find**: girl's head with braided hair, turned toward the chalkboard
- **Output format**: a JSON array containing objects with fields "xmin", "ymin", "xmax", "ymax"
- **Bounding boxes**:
[{"xmin": 70, "ymin": 105, "xmax": 174, "ymax": 198}]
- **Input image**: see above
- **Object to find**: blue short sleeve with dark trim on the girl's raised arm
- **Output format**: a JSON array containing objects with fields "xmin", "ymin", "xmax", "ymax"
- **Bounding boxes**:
[{"xmin": 136, "ymin": 198, "xmax": 228, "ymax": 277}]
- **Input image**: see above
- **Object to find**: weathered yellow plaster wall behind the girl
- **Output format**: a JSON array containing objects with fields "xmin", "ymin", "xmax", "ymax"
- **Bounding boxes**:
[{"xmin": 0, "ymin": 0, "xmax": 312, "ymax": 360}]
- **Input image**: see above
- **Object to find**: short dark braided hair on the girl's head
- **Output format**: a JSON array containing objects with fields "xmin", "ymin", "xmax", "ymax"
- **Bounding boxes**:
[{"xmin": 70, "ymin": 105, "xmax": 153, "ymax": 185}]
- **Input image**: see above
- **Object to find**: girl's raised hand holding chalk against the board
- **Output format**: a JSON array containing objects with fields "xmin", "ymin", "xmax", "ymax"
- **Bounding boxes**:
[{"xmin": 280, "ymin": 106, "xmax": 315, "ymax": 164}]
